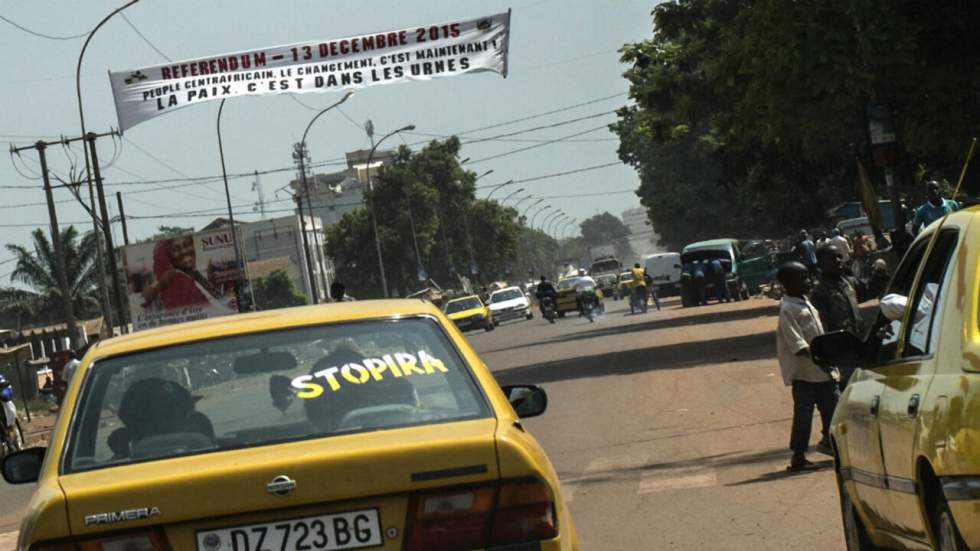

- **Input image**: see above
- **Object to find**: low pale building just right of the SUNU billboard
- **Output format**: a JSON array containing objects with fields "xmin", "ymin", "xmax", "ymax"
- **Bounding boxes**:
[{"xmin": 241, "ymin": 214, "xmax": 333, "ymax": 304}]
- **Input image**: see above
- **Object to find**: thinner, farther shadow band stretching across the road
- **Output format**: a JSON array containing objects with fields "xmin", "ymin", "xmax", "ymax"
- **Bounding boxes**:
[{"xmin": 483, "ymin": 301, "xmax": 779, "ymax": 354}]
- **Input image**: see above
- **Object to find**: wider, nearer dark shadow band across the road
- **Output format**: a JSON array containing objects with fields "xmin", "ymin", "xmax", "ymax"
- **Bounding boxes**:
[{"xmin": 493, "ymin": 331, "xmax": 776, "ymax": 384}]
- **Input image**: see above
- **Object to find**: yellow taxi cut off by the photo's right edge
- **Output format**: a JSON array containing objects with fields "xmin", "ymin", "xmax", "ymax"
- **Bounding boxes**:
[{"xmin": 811, "ymin": 208, "xmax": 980, "ymax": 551}]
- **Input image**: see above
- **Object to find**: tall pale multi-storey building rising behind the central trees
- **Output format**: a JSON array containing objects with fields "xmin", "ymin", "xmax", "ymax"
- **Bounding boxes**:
[{"xmin": 289, "ymin": 149, "xmax": 395, "ymax": 228}]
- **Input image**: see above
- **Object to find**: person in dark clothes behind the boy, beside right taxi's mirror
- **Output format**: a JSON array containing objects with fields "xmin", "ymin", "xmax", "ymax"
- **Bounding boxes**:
[{"xmin": 810, "ymin": 244, "xmax": 888, "ymax": 390}]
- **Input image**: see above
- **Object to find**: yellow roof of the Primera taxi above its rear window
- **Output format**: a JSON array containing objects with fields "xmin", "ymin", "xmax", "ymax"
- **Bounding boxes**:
[{"xmin": 89, "ymin": 299, "xmax": 440, "ymax": 358}]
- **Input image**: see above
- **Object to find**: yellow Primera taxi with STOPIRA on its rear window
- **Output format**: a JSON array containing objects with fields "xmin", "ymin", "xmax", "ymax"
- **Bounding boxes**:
[{"xmin": 2, "ymin": 300, "xmax": 578, "ymax": 551}]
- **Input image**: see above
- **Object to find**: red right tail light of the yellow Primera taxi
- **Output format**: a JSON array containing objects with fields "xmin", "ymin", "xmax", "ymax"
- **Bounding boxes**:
[{"xmin": 405, "ymin": 480, "xmax": 558, "ymax": 551}]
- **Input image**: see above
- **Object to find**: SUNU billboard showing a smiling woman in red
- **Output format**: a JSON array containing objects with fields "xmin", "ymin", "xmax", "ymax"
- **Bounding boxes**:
[{"xmin": 120, "ymin": 228, "xmax": 244, "ymax": 331}]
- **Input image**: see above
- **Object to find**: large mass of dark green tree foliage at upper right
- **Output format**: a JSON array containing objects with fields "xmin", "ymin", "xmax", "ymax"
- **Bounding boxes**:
[{"xmin": 613, "ymin": 0, "xmax": 980, "ymax": 247}]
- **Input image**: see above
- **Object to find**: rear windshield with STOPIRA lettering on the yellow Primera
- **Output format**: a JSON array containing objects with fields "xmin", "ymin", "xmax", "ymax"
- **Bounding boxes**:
[{"xmin": 64, "ymin": 318, "xmax": 489, "ymax": 472}]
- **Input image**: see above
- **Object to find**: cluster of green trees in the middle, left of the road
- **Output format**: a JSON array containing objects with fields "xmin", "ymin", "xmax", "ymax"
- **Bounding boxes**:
[{"xmin": 326, "ymin": 137, "xmax": 521, "ymax": 297}]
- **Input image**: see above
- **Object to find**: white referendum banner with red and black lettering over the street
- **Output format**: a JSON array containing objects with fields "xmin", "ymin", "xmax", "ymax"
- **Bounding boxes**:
[{"xmin": 109, "ymin": 11, "xmax": 510, "ymax": 130}]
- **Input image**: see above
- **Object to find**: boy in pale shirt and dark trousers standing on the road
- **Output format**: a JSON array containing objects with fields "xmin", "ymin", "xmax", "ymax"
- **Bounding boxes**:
[{"xmin": 776, "ymin": 261, "xmax": 837, "ymax": 471}]
